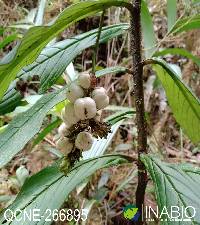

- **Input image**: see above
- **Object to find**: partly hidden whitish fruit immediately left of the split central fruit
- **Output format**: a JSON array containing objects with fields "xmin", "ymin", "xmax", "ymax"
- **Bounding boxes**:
[{"xmin": 61, "ymin": 103, "xmax": 80, "ymax": 127}]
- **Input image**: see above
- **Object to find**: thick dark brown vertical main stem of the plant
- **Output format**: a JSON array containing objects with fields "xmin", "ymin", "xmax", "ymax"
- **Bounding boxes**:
[{"xmin": 131, "ymin": 0, "xmax": 148, "ymax": 225}]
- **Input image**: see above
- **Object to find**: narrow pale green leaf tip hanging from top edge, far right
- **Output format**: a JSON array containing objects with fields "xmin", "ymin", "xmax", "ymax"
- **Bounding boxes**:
[{"xmin": 167, "ymin": 0, "xmax": 177, "ymax": 32}]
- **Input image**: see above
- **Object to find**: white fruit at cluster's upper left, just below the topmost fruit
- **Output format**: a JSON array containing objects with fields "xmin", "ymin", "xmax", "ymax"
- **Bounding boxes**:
[{"xmin": 66, "ymin": 83, "xmax": 84, "ymax": 103}]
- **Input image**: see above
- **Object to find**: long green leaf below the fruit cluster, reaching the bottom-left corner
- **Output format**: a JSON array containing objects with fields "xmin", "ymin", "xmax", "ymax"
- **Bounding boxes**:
[{"xmin": 0, "ymin": 155, "xmax": 129, "ymax": 225}]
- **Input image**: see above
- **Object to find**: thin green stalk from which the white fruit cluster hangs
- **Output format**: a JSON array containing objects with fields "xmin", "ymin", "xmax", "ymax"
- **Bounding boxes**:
[{"xmin": 92, "ymin": 10, "xmax": 105, "ymax": 74}]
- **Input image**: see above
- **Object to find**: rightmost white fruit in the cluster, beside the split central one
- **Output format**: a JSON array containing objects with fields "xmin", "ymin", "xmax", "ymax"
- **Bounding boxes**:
[{"xmin": 92, "ymin": 87, "xmax": 109, "ymax": 109}]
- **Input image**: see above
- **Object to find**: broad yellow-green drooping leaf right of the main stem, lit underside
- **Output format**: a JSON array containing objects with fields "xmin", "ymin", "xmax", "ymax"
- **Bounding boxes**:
[{"xmin": 153, "ymin": 59, "xmax": 200, "ymax": 143}]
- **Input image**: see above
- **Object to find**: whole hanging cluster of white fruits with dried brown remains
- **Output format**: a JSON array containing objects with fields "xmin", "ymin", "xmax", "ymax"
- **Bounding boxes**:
[{"xmin": 56, "ymin": 72, "xmax": 110, "ymax": 171}]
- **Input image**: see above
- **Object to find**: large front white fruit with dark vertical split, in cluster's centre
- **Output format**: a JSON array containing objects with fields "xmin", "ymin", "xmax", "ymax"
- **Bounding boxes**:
[{"xmin": 74, "ymin": 97, "xmax": 97, "ymax": 120}]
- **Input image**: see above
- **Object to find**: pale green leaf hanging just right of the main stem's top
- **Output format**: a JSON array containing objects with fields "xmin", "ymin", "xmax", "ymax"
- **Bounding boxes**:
[{"xmin": 141, "ymin": 0, "xmax": 157, "ymax": 58}]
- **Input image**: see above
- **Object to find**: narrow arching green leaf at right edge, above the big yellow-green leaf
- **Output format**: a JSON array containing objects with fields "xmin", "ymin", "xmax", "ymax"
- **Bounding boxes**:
[{"xmin": 154, "ymin": 48, "xmax": 200, "ymax": 66}]
